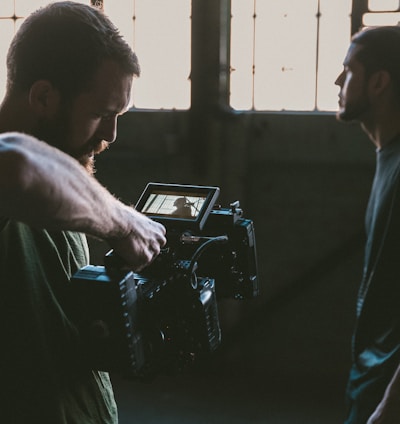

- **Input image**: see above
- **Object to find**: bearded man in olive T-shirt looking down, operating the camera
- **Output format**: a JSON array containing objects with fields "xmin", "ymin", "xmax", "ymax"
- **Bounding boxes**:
[{"xmin": 0, "ymin": 1, "xmax": 166, "ymax": 424}]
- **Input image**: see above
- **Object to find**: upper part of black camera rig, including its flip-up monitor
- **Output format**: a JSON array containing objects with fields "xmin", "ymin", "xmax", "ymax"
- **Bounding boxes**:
[{"xmin": 136, "ymin": 183, "xmax": 259, "ymax": 299}]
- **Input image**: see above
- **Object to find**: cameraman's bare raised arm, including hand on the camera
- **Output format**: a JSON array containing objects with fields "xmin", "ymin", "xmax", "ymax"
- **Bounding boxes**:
[{"xmin": 0, "ymin": 133, "xmax": 166, "ymax": 270}]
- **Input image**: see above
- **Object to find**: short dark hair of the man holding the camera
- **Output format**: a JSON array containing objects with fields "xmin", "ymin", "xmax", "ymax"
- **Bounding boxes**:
[{"xmin": 7, "ymin": 1, "xmax": 140, "ymax": 98}]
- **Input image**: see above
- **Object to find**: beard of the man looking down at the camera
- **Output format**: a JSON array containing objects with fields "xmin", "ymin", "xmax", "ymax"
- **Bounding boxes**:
[{"xmin": 33, "ymin": 114, "xmax": 109, "ymax": 175}]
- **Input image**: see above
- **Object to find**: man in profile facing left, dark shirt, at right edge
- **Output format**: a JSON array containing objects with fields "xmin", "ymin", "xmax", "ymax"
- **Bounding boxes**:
[{"xmin": 336, "ymin": 26, "xmax": 400, "ymax": 424}]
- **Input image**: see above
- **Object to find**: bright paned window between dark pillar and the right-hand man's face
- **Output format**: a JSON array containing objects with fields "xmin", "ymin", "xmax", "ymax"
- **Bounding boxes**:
[{"xmin": 231, "ymin": 0, "xmax": 351, "ymax": 110}]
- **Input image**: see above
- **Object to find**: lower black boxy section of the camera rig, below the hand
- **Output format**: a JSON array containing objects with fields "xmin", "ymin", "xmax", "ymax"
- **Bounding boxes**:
[{"xmin": 71, "ymin": 265, "xmax": 221, "ymax": 378}]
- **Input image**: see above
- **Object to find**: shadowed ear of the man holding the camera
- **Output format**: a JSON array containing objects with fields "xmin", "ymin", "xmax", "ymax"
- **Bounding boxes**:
[{"xmin": 29, "ymin": 80, "xmax": 60, "ymax": 118}]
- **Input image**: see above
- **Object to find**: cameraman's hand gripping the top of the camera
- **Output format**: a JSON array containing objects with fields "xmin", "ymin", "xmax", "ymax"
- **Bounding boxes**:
[{"xmin": 108, "ymin": 208, "xmax": 166, "ymax": 271}]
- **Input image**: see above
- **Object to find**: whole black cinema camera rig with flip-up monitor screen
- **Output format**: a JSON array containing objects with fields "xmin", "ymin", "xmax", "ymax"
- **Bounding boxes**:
[{"xmin": 70, "ymin": 183, "xmax": 258, "ymax": 378}]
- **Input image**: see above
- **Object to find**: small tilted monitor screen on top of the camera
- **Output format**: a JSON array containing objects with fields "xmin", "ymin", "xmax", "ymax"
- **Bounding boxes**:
[{"xmin": 136, "ymin": 183, "xmax": 219, "ymax": 230}]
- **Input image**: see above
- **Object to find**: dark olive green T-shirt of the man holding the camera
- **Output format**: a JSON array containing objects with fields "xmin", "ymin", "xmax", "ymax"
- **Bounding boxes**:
[{"xmin": 0, "ymin": 219, "xmax": 117, "ymax": 424}]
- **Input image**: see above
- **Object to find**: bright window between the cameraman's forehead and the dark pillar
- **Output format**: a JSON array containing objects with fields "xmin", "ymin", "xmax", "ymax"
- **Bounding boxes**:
[{"xmin": 104, "ymin": 0, "xmax": 191, "ymax": 109}]
